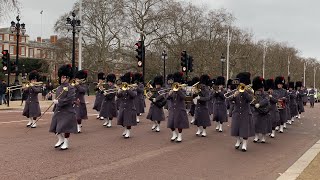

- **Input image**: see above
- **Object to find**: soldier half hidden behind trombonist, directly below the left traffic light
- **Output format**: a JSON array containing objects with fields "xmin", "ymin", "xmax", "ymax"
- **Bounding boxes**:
[{"xmin": 131, "ymin": 73, "xmax": 144, "ymax": 123}]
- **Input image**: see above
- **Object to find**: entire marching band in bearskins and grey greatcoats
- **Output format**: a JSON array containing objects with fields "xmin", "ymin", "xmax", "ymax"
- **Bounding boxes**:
[{"xmin": 23, "ymin": 65, "xmax": 314, "ymax": 152}]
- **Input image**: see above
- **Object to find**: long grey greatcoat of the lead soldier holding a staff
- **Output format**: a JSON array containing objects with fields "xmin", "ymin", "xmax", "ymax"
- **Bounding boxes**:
[{"xmin": 49, "ymin": 83, "xmax": 78, "ymax": 134}]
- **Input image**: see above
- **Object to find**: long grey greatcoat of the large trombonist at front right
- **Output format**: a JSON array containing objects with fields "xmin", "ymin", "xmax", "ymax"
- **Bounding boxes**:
[{"xmin": 230, "ymin": 91, "xmax": 255, "ymax": 138}]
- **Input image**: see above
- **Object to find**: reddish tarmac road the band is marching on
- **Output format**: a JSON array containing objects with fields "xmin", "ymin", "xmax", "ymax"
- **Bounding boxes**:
[{"xmin": 0, "ymin": 96, "xmax": 320, "ymax": 180}]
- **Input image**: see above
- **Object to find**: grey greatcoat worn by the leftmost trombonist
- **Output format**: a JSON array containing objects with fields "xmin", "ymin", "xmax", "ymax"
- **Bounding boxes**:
[{"xmin": 22, "ymin": 86, "xmax": 41, "ymax": 118}]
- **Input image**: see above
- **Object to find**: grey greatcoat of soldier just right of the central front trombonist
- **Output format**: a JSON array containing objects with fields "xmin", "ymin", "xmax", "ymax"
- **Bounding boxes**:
[{"xmin": 194, "ymin": 85, "xmax": 211, "ymax": 127}]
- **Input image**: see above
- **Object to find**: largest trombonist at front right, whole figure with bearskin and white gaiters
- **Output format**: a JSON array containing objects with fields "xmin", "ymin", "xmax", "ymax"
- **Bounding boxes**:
[{"xmin": 230, "ymin": 72, "xmax": 255, "ymax": 152}]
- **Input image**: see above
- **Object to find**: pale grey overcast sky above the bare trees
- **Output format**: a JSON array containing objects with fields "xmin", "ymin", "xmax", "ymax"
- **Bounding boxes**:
[{"xmin": 1, "ymin": 0, "xmax": 320, "ymax": 60}]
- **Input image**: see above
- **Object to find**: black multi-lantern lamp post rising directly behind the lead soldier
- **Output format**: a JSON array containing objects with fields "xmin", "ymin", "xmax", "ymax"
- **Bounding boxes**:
[{"xmin": 66, "ymin": 12, "xmax": 81, "ymax": 76}]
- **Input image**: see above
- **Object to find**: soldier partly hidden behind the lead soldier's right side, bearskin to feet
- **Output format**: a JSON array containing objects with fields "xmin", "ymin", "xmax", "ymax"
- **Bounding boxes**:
[{"xmin": 73, "ymin": 70, "xmax": 88, "ymax": 133}]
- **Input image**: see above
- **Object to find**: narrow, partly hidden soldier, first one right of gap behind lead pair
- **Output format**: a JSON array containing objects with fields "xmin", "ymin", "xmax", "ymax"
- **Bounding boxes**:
[{"xmin": 93, "ymin": 72, "xmax": 105, "ymax": 120}]
